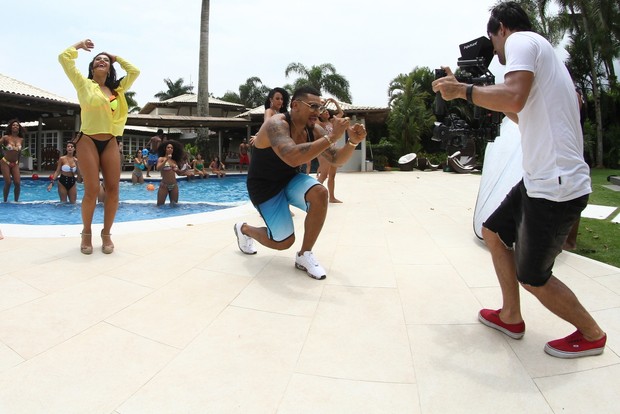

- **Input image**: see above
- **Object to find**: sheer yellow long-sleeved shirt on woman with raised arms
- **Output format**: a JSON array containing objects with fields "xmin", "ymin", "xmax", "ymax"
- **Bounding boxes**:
[{"xmin": 58, "ymin": 46, "xmax": 140, "ymax": 137}]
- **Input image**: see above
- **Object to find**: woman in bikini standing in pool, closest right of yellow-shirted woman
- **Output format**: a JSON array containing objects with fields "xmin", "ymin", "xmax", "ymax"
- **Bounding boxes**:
[{"xmin": 156, "ymin": 140, "xmax": 183, "ymax": 206}]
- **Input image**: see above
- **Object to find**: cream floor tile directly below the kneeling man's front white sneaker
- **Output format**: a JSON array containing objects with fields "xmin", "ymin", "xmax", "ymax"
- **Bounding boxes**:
[{"xmin": 297, "ymin": 285, "xmax": 415, "ymax": 383}]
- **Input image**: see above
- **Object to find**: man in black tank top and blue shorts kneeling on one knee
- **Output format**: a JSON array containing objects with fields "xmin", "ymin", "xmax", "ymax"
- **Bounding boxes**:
[{"xmin": 234, "ymin": 86, "xmax": 366, "ymax": 280}]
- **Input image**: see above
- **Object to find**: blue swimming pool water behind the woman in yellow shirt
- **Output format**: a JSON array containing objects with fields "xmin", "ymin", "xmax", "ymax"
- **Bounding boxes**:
[{"xmin": 0, "ymin": 176, "xmax": 249, "ymax": 225}]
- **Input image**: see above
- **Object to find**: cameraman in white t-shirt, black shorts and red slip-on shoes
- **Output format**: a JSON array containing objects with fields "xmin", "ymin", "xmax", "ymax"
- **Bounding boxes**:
[{"xmin": 433, "ymin": 2, "xmax": 607, "ymax": 358}]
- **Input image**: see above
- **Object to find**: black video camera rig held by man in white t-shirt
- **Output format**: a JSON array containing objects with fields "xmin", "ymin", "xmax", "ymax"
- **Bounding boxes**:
[{"xmin": 432, "ymin": 36, "xmax": 502, "ymax": 150}]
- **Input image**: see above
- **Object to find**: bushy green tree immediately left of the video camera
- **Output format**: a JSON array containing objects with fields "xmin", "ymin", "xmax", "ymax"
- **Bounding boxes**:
[{"xmin": 387, "ymin": 67, "xmax": 435, "ymax": 154}]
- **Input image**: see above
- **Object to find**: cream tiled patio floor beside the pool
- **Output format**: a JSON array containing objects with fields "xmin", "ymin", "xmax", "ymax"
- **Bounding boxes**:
[{"xmin": 0, "ymin": 171, "xmax": 620, "ymax": 414}]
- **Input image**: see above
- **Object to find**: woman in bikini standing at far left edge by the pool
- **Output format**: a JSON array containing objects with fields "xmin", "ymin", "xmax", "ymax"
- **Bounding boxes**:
[{"xmin": 0, "ymin": 119, "xmax": 26, "ymax": 203}]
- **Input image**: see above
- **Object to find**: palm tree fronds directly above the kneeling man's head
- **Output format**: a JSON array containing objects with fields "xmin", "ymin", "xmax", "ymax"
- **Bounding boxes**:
[{"xmin": 284, "ymin": 63, "xmax": 351, "ymax": 103}]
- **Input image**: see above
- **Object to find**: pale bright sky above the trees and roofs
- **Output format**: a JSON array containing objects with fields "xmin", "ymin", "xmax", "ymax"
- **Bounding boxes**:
[{"xmin": 0, "ymin": 0, "xmax": 503, "ymax": 107}]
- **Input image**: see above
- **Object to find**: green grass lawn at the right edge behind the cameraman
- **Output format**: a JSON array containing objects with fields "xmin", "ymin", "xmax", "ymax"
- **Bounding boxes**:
[{"xmin": 573, "ymin": 169, "xmax": 620, "ymax": 267}]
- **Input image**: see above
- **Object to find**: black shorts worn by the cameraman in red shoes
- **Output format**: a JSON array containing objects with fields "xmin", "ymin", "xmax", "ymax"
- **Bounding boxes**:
[{"xmin": 482, "ymin": 180, "xmax": 589, "ymax": 286}]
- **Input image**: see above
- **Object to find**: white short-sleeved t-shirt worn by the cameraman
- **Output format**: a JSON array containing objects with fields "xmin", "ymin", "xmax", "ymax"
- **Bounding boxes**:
[{"xmin": 505, "ymin": 32, "xmax": 592, "ymax": 201}]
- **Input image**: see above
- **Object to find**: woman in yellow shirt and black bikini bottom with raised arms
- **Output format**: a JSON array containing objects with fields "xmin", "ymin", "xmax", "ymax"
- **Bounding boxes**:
[{"xmin": 58, "ymin": 39, "xmax": 140, "ymax": 254}]
